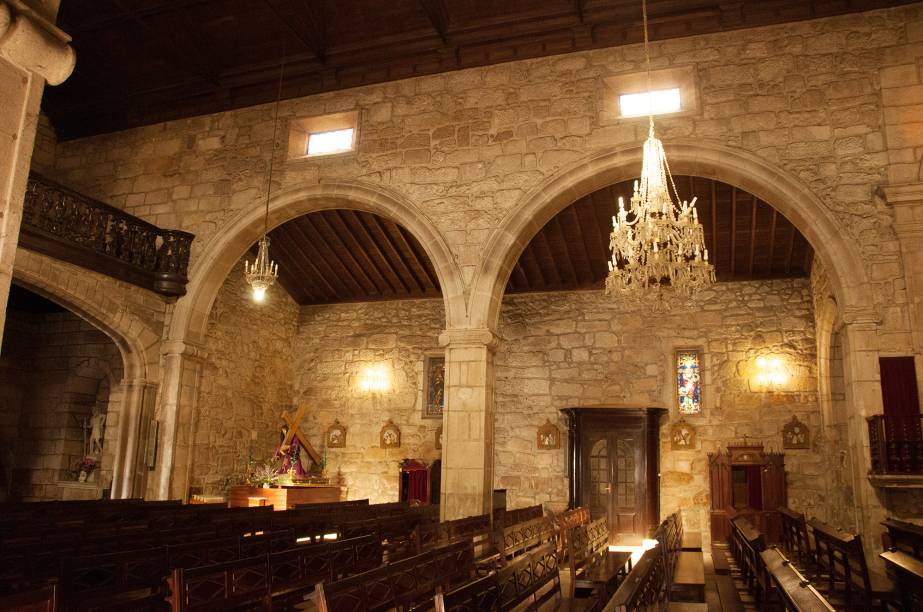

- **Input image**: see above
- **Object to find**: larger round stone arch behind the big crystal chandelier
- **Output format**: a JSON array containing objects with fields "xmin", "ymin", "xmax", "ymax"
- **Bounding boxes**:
[{"xmin": 468, "ymin": 139, "xmax": 870, "ymax": 329}]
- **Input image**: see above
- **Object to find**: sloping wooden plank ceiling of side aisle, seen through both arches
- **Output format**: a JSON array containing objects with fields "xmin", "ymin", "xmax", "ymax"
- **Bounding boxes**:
[{"xmin": 269, "ymin": 176, "xmax": 814, "ymax": 304}]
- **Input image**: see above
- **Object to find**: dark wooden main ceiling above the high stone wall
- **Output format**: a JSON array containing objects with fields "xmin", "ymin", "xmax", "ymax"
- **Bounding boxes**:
[{"xmin": 43, "ymin": 0, "xmax": 914, "ymax": 139}]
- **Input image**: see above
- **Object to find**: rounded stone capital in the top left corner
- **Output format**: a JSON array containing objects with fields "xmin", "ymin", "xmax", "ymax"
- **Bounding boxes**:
[{"xmin": 0, "ymin": 0, "xmax": 77, "ymax": 85}]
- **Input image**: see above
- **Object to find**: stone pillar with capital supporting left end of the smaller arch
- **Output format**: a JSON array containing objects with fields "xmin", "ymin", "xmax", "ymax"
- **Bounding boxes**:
[{"xmin": 152, "ymin": 340, "xmax": 206, "ymax": 501}]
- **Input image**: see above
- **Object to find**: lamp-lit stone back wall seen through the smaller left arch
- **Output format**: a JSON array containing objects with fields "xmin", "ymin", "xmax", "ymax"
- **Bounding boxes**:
[{"xmin": 295, "ymin": 300, "xmax": 445, "ymax": 503}]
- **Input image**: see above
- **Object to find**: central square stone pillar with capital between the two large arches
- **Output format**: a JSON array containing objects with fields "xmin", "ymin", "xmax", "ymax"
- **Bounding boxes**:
[{"xmin": 439, "ymin": 329, "xmax": 497, "ymax": 520}]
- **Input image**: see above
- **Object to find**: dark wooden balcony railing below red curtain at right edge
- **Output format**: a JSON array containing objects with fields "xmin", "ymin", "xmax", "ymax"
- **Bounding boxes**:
[{"xmin": 867, "ymin": 414, "xmax": 923, "ymax": 474}]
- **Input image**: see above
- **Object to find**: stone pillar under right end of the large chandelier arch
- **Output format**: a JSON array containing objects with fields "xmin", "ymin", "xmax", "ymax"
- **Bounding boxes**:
[{"xmin": 841, "ymin": 308, "xmax": 886, "ymax": 566}]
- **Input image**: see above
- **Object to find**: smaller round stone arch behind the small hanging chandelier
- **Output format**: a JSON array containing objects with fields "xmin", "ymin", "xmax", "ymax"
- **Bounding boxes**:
[{"xmin": 169, "ymin": 181, "xmax": 466, "ymax": 344}]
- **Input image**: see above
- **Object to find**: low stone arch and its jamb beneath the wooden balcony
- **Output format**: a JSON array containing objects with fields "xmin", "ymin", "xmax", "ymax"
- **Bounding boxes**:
[{"xmin": 13, "ymin": 248, "xmax": 160, "ymax": 497}]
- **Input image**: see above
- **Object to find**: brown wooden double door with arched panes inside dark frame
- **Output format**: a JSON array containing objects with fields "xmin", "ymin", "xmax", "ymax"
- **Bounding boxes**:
[{"xmin": 581, "ymin": 429, "xmax": 645, "ymax": 535}]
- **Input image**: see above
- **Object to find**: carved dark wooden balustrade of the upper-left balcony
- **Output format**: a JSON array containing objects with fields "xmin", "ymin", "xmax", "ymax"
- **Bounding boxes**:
[{"xmin": 19, "ymin": 173, "xmax": 194, "ymax": 296}]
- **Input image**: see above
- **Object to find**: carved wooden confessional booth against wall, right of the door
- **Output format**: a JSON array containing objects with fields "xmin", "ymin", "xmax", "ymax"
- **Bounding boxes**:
[{"xmin": 708, "ymin": 441, "xmax": 788, "ymax": 542}]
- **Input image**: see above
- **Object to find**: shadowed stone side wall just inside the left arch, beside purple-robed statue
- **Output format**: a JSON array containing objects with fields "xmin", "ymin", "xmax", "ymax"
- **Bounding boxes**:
[{"xmin": 190, "ymin": 256, "xmax": 298, "ymax": 494}]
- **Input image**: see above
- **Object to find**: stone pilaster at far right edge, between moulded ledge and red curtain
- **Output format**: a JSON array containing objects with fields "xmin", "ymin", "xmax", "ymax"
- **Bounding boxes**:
[{"xmin": 882, "ymin": 183, "xmax": 923, "ymax": 372}]
